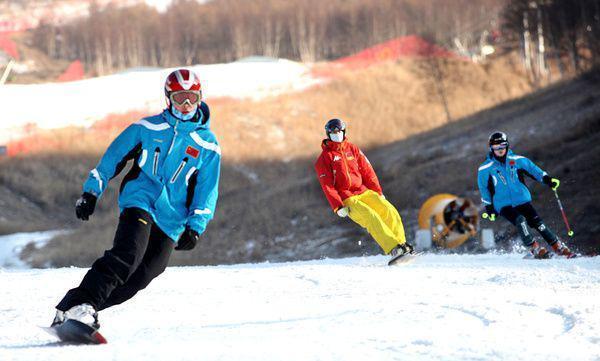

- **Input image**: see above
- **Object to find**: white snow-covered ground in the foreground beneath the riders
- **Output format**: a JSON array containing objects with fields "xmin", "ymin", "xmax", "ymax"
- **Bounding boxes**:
[{"xmin": 0, "ymin": 254, "xmax": 600, "ymax": 361}]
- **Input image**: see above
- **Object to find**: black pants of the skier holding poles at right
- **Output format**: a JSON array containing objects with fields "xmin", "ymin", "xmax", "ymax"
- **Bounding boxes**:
[{"xmin": 500, "ymin": 202, "xmax": 558, "ymax": 247}]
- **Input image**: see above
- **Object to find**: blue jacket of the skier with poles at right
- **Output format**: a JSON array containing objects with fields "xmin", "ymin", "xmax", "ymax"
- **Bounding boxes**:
[{"xmin": 477, "ymin": 150, "xmax": 546, "ymax": 212}]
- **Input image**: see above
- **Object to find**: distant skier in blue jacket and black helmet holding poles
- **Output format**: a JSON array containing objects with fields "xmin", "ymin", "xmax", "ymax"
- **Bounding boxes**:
[{"xmin": 477, "ymin": 132, "xmax": 575, "ymax": 258}]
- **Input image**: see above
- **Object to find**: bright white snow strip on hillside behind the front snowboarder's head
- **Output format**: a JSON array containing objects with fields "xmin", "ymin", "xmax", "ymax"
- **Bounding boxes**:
[{"xmin": 0, "ymin": 58, "xmax": 320, "ymax": 141}]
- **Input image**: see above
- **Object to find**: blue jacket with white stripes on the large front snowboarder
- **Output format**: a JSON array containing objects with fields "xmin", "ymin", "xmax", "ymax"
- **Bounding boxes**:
[{"xmin": 83, "ymin": 103, "xmax": 221, "ymax": 242}]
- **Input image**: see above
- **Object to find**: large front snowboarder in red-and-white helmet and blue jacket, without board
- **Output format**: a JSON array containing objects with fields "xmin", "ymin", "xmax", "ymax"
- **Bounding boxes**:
[{"xmin": 52, "ymin": 69, "xmax": 221, "ymax": 328}]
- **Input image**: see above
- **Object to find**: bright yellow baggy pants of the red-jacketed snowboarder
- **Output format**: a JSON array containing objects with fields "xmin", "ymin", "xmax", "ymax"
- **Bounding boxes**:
[{"xmin": 344, "ymin": 190, "xmax": 406, "ymax": 254}]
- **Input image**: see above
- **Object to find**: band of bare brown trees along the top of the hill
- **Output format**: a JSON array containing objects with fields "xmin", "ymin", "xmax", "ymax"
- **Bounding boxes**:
[{"xmin": 34, "ymin": 0, "xmax": 510, "ymax": 74}]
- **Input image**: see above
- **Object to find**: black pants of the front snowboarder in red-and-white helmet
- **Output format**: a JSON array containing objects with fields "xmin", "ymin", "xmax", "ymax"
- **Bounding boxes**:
[{"xmin": 56, "ymin": 208, "xmax": 174, "ymax": 311}]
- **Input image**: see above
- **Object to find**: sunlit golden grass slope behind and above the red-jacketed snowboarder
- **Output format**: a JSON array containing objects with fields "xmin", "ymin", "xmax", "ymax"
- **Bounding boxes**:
[{"xmin": 211, "ymin": 55, "xmax": 532, "ymax": 162}]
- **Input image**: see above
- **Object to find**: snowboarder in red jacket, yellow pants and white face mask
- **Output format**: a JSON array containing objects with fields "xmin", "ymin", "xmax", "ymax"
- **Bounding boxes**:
[{"xmin": 315, "ymin": 119, "xmax": 413, "ymax": 263}]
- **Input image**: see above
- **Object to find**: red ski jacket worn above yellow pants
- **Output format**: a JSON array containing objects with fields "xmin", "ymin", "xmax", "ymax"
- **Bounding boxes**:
[{"xmin": 315, "ymin": 139, "xmax": 382, "ymax": 212}]
